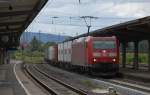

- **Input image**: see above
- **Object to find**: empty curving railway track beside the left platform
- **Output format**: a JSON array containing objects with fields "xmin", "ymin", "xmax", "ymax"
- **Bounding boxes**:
[{"xmin": 25, "ymin": 65, "xmax": 91, "ymax": 95}]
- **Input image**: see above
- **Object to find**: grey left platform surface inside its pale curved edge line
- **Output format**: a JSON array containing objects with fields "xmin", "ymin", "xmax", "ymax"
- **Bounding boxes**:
[{"xmin": 0, "ymin": 64, "xmax": 26, "ymax": 95}]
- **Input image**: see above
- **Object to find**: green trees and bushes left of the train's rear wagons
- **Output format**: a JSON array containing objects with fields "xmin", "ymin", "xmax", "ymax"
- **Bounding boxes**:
[{"xmin": 11, "ymin": 37, "xmax": 56, "ymax": 63}]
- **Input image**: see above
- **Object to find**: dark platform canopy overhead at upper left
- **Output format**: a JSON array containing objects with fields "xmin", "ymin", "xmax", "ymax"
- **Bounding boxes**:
[{"xmin": 0, "ymin": 0, "xmax": 48, "ymax": 48}]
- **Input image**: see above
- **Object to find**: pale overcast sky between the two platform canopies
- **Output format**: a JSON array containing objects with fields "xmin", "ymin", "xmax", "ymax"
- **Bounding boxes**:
[{"xmin": 26, "ymin": 0, "xmax": 150, "ymax": 36}]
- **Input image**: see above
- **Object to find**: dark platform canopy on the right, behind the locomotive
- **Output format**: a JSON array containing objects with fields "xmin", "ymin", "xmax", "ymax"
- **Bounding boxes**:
[{"xmin": 69, "ymin": 16, "xmax": 150, "ymax": 42}]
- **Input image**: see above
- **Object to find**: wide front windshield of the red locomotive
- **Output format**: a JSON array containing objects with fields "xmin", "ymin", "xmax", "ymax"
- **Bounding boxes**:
[{"xmin": 93, "ymin": 41, "xmax": 115, "ymax": 49}]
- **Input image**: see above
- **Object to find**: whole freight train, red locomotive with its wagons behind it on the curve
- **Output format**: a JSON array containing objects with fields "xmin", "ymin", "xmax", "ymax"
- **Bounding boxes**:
[{"xmin": 45, "ymin": 36, "xmax": 119, "ymax": 75}]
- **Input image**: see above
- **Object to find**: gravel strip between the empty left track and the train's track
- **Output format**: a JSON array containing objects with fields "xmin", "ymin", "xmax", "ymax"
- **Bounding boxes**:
[{"xmin": 36, "ymin": 64, "xmax": 116, "ymax": 93}]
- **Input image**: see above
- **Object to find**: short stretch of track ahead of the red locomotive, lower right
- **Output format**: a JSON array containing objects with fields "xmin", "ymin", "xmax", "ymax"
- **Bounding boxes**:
[{"xmin": 94, "ymin": 78, "xmax": 150, "ymax": 95}]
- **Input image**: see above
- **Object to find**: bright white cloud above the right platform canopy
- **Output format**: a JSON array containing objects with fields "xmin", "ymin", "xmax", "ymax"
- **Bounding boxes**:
[{"xmin": 108, "ymin": 2, "xmax": 150, "ymax": 18}]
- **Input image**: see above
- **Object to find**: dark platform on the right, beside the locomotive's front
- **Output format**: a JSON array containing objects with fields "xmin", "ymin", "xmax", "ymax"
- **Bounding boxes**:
[{"xmin": 120, "ymin": 68, "xmax": 150, "ymax": 83}]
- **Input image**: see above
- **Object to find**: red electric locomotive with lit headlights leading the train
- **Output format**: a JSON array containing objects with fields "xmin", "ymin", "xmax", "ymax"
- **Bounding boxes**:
[{"xmin": 72, "ymin": 36, "xmax": 119, "ymax": 73}]
